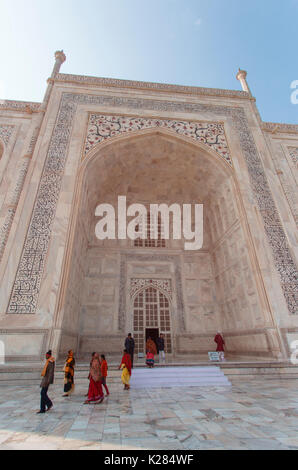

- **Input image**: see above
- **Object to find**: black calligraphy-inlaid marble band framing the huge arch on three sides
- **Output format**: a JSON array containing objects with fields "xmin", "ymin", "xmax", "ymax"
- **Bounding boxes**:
[{"xmin": 7, "ymin": 93, "xmax": 298, "ymax": 316}]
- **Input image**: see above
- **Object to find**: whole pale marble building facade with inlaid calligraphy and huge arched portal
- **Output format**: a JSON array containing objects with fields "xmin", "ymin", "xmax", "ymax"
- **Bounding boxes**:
[{"xmin": 0, "ymin": 56, "xmax": 298, "ymax": 361}]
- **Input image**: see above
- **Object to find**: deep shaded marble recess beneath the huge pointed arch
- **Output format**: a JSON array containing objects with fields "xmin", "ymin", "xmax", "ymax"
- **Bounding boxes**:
[{"xmin": 56, "ymin": 129, "xmax": 278, "ymax": 356}]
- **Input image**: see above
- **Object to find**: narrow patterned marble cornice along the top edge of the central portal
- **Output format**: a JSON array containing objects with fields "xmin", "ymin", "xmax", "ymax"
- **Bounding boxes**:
[{"xmin": 55, "ymin": 73, "xmax": 251, "ymax": 101}]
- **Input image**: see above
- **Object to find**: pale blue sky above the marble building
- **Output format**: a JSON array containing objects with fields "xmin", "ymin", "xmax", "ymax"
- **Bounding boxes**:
[{"xmin": 0, "ymin": 0, "xmax": 298, "ymax": 123}]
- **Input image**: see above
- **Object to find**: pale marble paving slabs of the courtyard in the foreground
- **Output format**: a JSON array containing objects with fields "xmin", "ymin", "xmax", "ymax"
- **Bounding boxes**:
[{"xmin": 0, "ymin": 377, "xmax": 298, "ymax": 450}]
